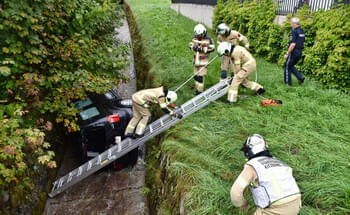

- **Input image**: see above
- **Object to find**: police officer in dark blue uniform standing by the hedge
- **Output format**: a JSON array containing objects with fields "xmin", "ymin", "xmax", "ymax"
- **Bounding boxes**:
[{"xmin": 284, "ymin": 17, "xmax": 305, "ymax": 86}]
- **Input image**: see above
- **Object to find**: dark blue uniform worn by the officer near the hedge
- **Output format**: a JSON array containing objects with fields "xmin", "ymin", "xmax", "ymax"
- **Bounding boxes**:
[{"xmin": 284, "ymin": 27, "xmax": 305, "ymax": 85}]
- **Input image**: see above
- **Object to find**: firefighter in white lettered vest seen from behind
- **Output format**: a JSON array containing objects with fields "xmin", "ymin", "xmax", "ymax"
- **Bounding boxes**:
[{"xmin": 231, "ymin": 134, "xmax": 301, "ymax": 215}]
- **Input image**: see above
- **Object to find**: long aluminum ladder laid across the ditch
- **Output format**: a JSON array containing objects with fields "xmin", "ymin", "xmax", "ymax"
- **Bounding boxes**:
[{"xmin": 49, "ymin": 78, "xmax": 231, "ymax": 198}]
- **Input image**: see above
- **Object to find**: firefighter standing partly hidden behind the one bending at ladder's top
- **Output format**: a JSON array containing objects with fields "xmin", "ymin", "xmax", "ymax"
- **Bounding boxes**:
[{"xmin": 216, "ymin": 23, "xmax": 249, "ymax": 80}]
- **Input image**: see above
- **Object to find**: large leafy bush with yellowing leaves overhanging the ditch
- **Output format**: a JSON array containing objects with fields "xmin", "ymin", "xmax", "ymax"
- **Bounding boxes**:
[{"xmin": 0, "ymin": 0, "xmax": 128, "ymax": 208}]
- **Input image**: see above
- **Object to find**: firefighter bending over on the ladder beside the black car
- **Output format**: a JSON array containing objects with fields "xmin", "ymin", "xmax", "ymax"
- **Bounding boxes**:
[{"xmin": 125, "ymin": 87, "xmax": 182, "ymax": 139}]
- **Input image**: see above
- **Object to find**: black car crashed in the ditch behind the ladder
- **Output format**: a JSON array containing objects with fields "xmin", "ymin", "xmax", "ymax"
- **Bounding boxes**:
[{"xmin": 74, "ymin": 87, "xmax": 138, "ymax": 169}]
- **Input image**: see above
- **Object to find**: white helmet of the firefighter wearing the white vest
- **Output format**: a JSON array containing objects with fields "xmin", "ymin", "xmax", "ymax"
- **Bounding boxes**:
[{"xmin": 241, "ymin": 134, "xmax": 268, "ymax": 159}]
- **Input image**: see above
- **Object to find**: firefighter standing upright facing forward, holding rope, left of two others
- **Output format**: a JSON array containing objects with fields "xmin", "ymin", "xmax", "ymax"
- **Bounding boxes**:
[{"xmin": 189, "ymin": 24, "xmax": 215, "ymax": 95}]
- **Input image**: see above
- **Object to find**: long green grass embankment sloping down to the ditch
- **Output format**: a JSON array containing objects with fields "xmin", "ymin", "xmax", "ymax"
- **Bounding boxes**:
[{"xmin": 127, "ymin": 0, "xmax": 350, "ymax": 214}]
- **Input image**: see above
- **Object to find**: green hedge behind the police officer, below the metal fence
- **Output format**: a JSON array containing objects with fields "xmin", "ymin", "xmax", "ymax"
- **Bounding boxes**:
[{"xmin": 213, "ymin": 0, "xmax": 350, "ymax": 93}]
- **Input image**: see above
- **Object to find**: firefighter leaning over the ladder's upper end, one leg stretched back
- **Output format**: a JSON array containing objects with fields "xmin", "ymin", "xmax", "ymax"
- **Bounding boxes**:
[{"xmin": 218, "ymin": 42, "xmax": 265, "ymax": 104}]
